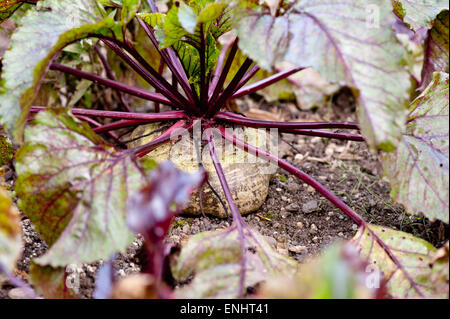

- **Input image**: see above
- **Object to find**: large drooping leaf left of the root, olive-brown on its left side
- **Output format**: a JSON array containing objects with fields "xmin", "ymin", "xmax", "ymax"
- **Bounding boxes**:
[{"xmin": 16, "ymin": 109, "xmax": 154, "ymax": 267}]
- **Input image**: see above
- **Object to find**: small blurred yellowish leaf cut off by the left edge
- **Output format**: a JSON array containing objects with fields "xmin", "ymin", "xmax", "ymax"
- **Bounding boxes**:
[{"xmin": 0, "ymin": 187, "xmax": 22, "ymax": 271}]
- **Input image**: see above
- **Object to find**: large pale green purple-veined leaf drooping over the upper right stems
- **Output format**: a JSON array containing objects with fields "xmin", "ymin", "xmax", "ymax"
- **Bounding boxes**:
[{"xmin": 236, "ymin": 0, "xmax": 411, "ymax": 151}]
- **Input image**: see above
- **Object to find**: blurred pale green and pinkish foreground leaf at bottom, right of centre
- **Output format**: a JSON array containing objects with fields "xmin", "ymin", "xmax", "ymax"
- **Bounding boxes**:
[{"xmin": 257, "ymin": 244, "xmax": 386, "ymax": 299}]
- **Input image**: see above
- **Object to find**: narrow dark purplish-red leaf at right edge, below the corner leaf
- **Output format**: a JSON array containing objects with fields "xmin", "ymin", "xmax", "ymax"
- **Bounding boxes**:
[{"xmin": 420, "ymin": 10, "xmax": 449, "ymax": 89}]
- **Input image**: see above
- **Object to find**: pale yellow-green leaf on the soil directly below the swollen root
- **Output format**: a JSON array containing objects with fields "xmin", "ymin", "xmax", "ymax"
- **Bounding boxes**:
[{"xmin": 171, "ymin": 229, "xmax": 297, "ymax": 298}]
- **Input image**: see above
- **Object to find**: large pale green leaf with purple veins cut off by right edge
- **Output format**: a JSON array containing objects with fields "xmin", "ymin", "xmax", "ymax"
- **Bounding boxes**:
[{"xmin": 383, "ymin": 73, "xmax": 449, "ymax": 223}]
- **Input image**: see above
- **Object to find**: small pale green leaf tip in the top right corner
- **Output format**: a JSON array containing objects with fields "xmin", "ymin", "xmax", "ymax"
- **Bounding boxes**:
[{"xmin": 391, "ymin": 0, "xmax": 448, "ymax": 30}]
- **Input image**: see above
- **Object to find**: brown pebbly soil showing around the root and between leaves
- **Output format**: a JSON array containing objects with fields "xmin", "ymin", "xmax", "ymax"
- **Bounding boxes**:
[{"xmin": 0, "ymin": 91, "xmax": 448, "ymax": 298}]
